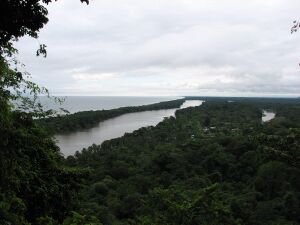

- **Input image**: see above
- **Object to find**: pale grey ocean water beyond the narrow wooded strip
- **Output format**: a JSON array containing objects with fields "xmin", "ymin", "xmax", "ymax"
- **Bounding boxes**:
[{"xmin": 40, "ymin": 96, "xmax": 182, "ymax": 113}]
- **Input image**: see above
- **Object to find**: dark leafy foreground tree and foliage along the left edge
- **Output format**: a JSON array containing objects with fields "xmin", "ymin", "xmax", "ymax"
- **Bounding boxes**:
[{"xmin": 0, "ymin": 0, "xmax": 88, "ymax": 225}]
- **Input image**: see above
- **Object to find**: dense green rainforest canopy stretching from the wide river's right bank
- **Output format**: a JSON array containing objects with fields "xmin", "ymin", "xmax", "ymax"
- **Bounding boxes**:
[{"xmin": 63, "ymin": 98, "xmax": 300, "ymax": 225}]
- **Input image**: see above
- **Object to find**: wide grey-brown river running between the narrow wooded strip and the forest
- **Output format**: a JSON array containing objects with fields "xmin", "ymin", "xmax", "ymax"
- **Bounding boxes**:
[{"xmin": 55, "ymin": 100, "xmax": 203, "ymax": 156}]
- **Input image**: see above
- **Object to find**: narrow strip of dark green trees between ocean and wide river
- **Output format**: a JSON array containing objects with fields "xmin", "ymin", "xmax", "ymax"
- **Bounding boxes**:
[{"xmin": 38, "ymin": 99, "xmax": 185, "ymax": 134}]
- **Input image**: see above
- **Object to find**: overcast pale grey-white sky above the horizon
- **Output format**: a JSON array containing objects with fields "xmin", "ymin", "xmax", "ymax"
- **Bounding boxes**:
[{"xmin": 17, "ymin": 0, "xmax": 300, "ymax": 96}]
